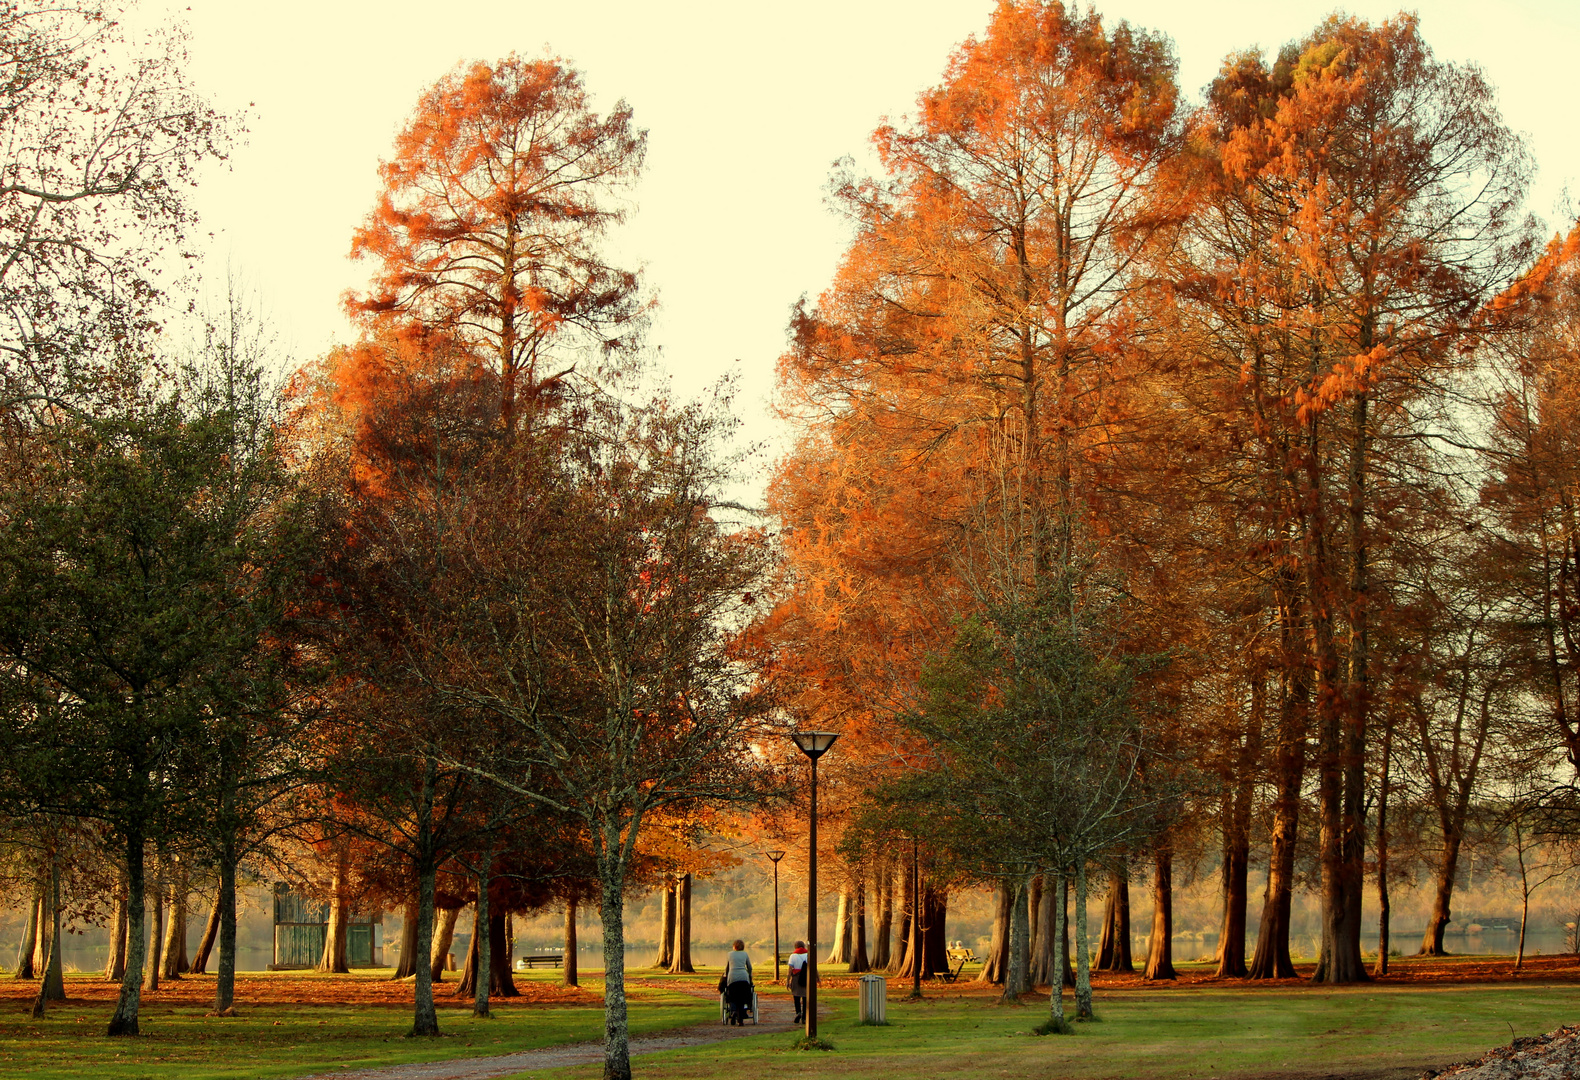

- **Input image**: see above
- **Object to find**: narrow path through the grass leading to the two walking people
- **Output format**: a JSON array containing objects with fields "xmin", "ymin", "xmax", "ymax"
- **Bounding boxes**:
[{"xmin": 300, "ymin": 987, "xmax": 823, "ymax": 1080}]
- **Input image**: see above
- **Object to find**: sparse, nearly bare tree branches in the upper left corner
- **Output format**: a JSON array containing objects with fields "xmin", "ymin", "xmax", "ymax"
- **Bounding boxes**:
[{"xmin": 0, "ymin": 0, "xmax": 232, "ymax": 407}]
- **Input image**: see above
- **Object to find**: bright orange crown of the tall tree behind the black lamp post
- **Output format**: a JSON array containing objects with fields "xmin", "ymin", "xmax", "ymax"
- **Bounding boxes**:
[{"xmin": 763, "ymin": 2, "xmax": 1179, "ymax": 978}]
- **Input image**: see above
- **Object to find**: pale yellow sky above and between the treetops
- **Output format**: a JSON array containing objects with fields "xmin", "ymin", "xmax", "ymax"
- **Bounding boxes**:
[{"xmin": 139, "ymin": 0, "xmax": 1580, "ymax": 476}]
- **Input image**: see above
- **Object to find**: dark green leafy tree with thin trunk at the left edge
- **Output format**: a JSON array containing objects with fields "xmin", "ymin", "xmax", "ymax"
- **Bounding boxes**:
[{"xmin": 0, "ymin": 366, "xmax": 311, "ymax": 1034}]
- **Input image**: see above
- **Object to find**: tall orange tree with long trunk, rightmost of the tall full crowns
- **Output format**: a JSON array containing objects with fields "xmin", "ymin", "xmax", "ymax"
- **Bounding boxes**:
[{"xmin": 1172, "ymin": 16, "xmax": 1529, "ymax": 982}]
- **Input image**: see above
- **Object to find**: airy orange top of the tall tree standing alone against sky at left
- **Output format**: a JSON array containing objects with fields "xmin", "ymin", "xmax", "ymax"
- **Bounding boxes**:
[{"xmin": 346, "ymin": 54, "xmax": 648, "ymax": 431}]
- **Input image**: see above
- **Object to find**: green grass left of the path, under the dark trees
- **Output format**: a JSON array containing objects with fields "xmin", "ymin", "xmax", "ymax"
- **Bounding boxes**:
[{"xmin": 0, "ymin": 979, "xmax": 717, "ymax": 1080}]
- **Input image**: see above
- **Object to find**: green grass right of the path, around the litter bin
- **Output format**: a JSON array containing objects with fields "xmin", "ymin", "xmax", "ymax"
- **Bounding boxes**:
[{"xmin": 512, "ymin": 984, "xmax": 1580, "ymax": 1080}]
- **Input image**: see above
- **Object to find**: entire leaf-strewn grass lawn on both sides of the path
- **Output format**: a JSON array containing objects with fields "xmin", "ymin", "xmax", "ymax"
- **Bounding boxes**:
[{"xmin": 0, "ymin": 965, "xmax": 1580, "ymax": 1080}]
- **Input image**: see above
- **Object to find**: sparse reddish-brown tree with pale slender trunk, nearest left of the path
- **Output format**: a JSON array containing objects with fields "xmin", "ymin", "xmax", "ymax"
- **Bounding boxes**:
[{"xmin": 430, "ymin": 382, "xmax": 780, "ymax": 1078}]
